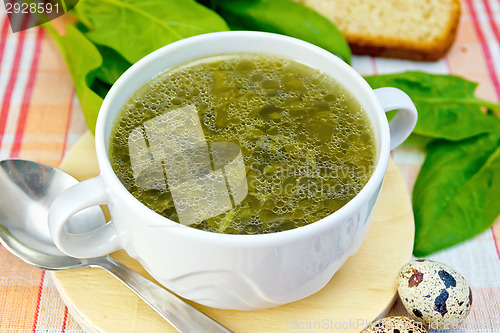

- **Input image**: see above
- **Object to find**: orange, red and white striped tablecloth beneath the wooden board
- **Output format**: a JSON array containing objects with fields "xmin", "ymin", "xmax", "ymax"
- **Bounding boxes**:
[{"xmin": 0, "ymin": 0, "xmax": 500, "ymax": 333}]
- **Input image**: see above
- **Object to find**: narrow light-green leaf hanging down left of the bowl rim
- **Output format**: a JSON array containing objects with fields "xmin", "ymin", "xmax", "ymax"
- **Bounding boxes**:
[{"xmin": 44, "ymin": 23, "xmax": 103, "ymax": 131}]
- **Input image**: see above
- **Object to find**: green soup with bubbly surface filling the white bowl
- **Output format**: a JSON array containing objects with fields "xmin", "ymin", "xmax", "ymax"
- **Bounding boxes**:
[{"xmin": 109, "ymin": 53, "xmax": 376, "ymax": 234}]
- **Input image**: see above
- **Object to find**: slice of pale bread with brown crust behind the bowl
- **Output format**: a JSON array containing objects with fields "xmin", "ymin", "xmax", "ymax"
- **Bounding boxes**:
[{"xmin": 297, "ymin": 0, "xmax": 460, "ymax": 61}]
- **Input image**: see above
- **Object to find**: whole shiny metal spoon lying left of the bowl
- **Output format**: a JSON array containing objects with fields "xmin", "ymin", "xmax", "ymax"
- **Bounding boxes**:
[{"xmin": 0, "ymin": 160, "xmax": 232, "ymax": 333}]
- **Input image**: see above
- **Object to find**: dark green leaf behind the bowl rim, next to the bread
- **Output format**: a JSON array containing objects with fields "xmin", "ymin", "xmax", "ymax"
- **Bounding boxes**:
[{"xmin": 213, "ymin": 0, "xmax": 351, "ymax": 63}]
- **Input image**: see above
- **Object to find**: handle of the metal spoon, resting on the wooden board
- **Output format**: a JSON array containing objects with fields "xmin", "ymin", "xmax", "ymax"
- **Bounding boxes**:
[{"xmin": 90, "ymin": 256, "xmax": 232, "ymax": 333}]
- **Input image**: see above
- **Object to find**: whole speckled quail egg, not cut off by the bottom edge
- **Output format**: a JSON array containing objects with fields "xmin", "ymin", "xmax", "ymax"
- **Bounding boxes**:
[{"xmin": 398, "ymin": 260, "xmax": 472, "ymax": 329}]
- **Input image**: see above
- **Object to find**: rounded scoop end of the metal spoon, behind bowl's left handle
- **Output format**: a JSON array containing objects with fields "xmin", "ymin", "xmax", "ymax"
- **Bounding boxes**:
[{"xmin": 0, "ymin": 160, "xmax": 105, "ymax": 270}]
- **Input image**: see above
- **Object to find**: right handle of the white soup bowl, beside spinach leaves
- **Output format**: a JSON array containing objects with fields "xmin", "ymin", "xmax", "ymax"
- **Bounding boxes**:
[{"xmin": 374, "ymin": 87, "xmax": 418, "ymax": 150}]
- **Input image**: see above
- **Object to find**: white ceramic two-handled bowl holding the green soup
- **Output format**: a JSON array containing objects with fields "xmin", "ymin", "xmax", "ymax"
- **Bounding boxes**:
[{"xmin": 49, "ymin": 32, "xmax": 417, "ymax": 310}]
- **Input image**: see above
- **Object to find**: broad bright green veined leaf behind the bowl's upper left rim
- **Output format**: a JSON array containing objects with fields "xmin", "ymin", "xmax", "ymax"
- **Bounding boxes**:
[{"xmin": 74, "ymin": 0, "xmax": 229, "ymax": 63}]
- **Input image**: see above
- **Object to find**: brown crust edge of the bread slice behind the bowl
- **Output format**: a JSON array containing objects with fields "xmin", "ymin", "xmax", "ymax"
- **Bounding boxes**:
[{"xmin": 302, "ymin": 0, "xmax": 461, "ymax": 61}]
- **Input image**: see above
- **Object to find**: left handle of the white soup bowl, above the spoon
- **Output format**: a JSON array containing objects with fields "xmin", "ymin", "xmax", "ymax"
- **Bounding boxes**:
[{"xmin": 48, "ymin": 176, "xmax": 121, "ymax": 258}]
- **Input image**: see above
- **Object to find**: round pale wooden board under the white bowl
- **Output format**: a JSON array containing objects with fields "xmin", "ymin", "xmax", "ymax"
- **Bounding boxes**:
[{"xmin": 52, "ymin": 134, "xmax": 414, "ymax": 333}]
